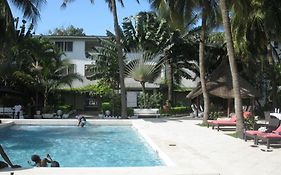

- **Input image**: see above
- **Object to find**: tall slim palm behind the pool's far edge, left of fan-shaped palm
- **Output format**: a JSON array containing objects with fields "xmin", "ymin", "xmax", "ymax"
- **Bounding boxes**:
[{"xmin": 62, "ymin": 0, "xmax": 139, "ymax": 118}]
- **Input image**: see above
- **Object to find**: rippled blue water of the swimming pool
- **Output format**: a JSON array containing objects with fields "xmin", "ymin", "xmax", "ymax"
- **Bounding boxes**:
[{"xmin": 0, "ymin": 125, "xmax": 163, "ymax": 167}]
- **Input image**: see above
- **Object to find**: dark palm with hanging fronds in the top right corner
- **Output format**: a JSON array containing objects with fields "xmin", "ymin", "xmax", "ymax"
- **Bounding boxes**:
[{"xmin": 232, "ymin": 0, "xmax": 281, "ymax": 107}]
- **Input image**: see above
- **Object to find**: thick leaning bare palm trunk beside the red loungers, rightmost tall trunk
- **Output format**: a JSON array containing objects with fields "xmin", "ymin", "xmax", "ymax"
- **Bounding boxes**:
[{"xmin": 220, "ymin": 0, "xmax": 244, "ymax": 138}]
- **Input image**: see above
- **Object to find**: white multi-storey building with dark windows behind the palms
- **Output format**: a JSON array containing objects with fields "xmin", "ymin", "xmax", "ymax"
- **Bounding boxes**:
[{"xmin": 44, "ymin": 35, "xmax": 197, "ymax": 109}]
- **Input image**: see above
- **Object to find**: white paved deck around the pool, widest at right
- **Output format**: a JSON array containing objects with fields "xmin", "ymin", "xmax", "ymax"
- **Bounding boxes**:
[{"xmin": 0, "ymin": 118, "xmax": 281, "ymax": 175}]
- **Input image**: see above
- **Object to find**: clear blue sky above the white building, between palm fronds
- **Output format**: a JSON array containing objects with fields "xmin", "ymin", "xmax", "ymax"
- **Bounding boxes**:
[{"xmin": 11, "ymin": 0, "xmax": 151, "ymax": 36}]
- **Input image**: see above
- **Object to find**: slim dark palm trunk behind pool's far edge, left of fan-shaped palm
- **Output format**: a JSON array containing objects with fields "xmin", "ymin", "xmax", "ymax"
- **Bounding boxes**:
[{"xmin": 111, "ymin": 0, "xmax": 127, "ymax": 118}]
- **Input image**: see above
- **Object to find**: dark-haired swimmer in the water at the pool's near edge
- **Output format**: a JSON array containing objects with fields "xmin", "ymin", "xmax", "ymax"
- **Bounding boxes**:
[{"xmin": 28, "ymin": 154, "xmax": 60, "ymax": 167}]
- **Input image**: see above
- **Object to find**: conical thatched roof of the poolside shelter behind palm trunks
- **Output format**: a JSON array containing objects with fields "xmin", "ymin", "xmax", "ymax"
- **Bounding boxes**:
[{"xmin": 187, "ymin": 61, "xmax": 259, "ymax": 99}]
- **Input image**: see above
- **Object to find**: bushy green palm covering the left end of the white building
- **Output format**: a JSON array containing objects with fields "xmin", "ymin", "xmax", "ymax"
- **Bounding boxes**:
[{"xmin": 13, "ymin": 38, "xmax": 82, "ymax": 109}]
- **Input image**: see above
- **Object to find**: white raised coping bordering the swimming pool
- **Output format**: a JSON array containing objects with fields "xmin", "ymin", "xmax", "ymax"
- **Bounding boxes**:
[{"xmin": 0, "ymin": 119, "xmax": 179, "ymax": 175}]
